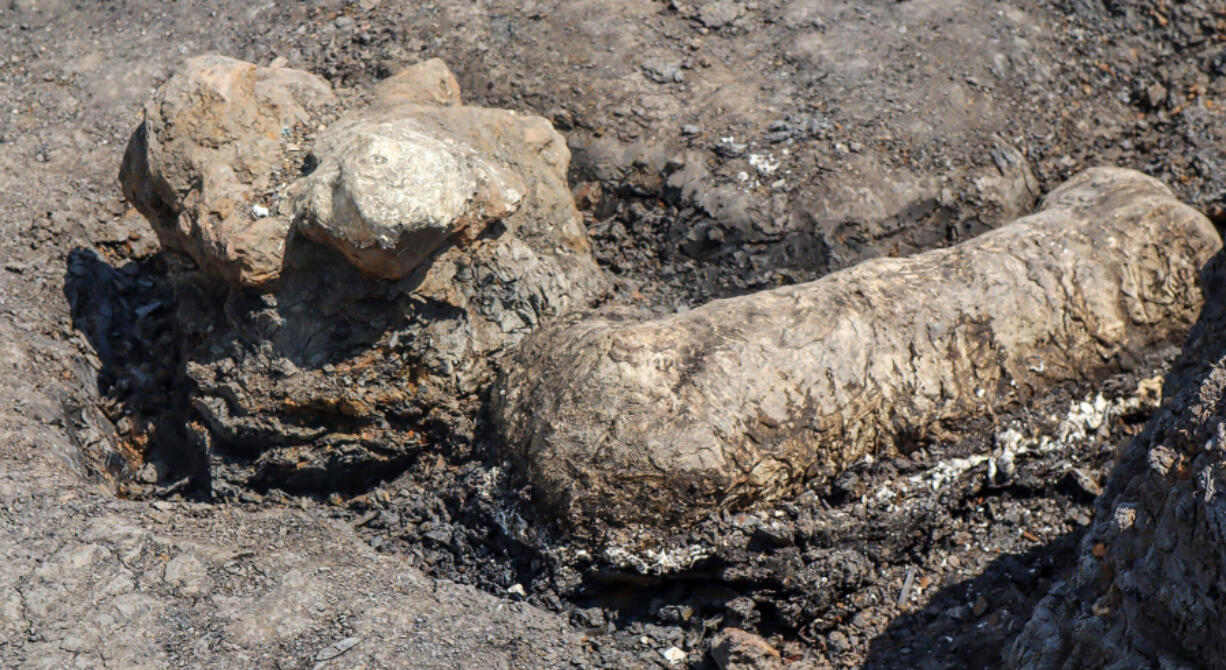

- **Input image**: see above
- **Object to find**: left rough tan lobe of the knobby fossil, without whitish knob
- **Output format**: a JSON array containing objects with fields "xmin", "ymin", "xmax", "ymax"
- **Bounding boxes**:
[{"xmin": 120, "ymin": 55, "xmax": 335, "ymax": 286}]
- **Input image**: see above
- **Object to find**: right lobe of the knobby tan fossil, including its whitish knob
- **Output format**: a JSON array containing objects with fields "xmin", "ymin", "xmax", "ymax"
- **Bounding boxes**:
[{"xmin": 291, "ymin": 59, "xmax": 587, "ymax": 279}]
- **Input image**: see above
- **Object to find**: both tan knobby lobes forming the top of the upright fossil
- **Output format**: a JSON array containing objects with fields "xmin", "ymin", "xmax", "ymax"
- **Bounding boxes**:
[{"xmin": 120, "ymin": 55, "xmax": 586, "ymax": 287}]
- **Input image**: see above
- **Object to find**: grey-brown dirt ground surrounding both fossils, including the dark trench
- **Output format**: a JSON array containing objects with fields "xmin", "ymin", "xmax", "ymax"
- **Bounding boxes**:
[{"xmin": 0, "ymin": 0, "xmax": 1226, "ymax": 668}]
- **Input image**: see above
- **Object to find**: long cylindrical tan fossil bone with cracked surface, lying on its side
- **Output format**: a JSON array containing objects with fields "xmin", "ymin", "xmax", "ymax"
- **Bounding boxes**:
[{"xmin": 494, "ymin": 168, "xmax": 1221, "ymax": 526}]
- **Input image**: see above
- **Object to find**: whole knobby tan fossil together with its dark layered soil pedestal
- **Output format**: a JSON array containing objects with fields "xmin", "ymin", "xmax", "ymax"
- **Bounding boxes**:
[{"xmin": 123, "ymin": 56, "xmax": 606, "ymax": 490}]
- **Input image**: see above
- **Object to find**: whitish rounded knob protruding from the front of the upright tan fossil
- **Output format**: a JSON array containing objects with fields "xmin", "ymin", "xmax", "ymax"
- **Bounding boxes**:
[{"xmin": 292, "ymin": 115, "xmax": 525, "ymax": 279}]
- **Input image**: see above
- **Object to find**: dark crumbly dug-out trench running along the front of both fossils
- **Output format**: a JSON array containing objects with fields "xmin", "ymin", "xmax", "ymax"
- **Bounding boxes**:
[{"xmin": 65, "ymin": 201, "xmax": 1196, "ymax": 668}]
